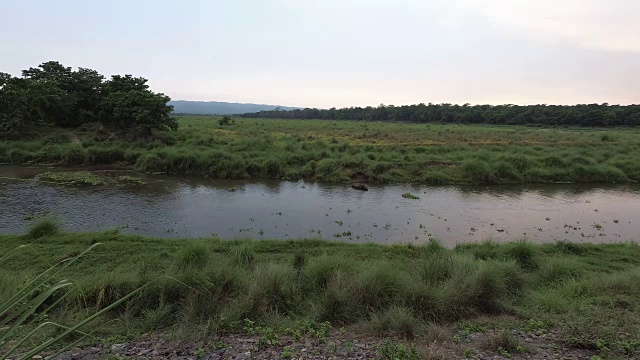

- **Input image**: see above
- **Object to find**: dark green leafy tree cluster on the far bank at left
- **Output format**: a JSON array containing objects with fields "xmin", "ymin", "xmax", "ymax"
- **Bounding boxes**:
[{"xmin": 0, "ymin": 61, "xmax": 178, "ymax": 133}]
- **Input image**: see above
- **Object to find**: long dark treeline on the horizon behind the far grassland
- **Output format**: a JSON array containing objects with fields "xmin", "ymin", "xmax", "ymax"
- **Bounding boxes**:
[{"xmin": 241, "ymin": 103, "xmax": 640, "ymax": 127}]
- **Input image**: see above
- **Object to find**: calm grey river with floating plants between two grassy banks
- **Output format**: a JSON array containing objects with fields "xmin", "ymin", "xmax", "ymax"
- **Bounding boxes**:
[{"xmin": 0, "ymin": 166, "xmax": 640, "ymax": 245}]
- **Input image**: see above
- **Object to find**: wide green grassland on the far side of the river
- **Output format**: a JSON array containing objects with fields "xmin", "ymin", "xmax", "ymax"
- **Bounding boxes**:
[{"xmin": 0, "ymin": 117, "xmax": 640, "ymax": 184}]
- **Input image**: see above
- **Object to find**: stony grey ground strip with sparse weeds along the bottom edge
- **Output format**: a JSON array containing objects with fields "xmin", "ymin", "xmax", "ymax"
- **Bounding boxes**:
[{"xmin": 46, "ymin": 329, "xmax": 595, "ymax": 360}]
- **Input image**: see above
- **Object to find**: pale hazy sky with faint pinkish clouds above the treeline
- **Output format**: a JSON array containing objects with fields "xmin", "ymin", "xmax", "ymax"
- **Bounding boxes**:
[{"xmin": 0, "ymin": 0, "xmax": 640, "ymax": 107}]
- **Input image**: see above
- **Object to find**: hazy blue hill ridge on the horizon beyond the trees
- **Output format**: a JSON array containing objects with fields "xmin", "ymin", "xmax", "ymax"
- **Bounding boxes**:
[{"xmin": 169, "ymin": 100, "xmax": 300, "ymax": 115}]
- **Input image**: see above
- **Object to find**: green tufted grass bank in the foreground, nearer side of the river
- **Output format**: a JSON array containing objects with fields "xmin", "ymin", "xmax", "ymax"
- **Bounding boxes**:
[{"xmin": 0, "ymin": 229, "xmax": 640, "ymax": 356}]
